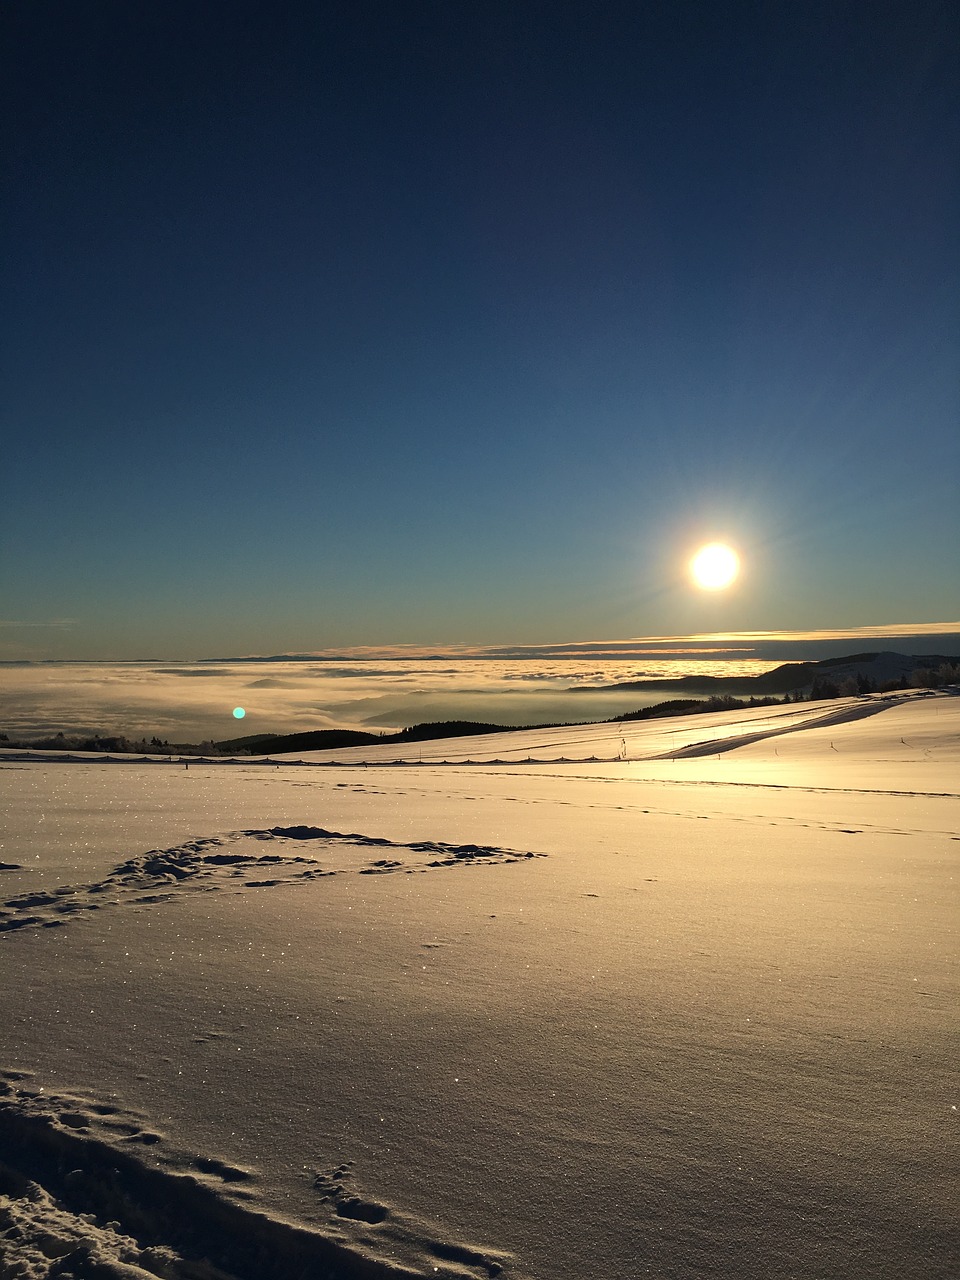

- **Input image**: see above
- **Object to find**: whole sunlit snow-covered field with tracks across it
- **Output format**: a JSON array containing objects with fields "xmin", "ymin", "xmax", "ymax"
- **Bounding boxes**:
[{"xmin": 0, "ymin": 694, "xmax": 960, "ymax": 1280}]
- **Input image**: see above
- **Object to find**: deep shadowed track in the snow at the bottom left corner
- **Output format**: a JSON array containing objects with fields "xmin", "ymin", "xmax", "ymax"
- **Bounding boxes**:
[{"xmin": 0, "ymin": 1070, "xmax": 520, "ymax": 1280}]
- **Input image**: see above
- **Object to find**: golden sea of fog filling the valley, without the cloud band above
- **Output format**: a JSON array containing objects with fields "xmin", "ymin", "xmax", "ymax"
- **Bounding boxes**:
[{"xmin": 0, "ymin": 659, "xmax": 771, "ymax": 742}]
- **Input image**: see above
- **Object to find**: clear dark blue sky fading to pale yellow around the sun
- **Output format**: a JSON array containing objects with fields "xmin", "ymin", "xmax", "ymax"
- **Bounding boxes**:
[{"xmin": 0, "ymin": 0, "xmax": 960, "ymax": 658}]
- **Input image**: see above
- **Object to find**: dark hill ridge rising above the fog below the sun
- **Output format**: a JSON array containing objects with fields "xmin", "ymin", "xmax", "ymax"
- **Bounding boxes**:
[{"xmin": 568, "ymin": 652, "xmax": 960, "ymax": 694}]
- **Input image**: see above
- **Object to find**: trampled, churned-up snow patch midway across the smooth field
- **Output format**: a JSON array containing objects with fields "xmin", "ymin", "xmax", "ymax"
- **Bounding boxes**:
[{"xmin": 0, "ymin": 826, "xmax": 547, "ymax": 933}]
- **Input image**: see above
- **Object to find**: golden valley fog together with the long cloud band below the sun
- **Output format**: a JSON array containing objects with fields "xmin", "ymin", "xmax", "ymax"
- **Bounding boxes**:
[{"xmin": 0, "ymin": 623, "xmax": 960, "ymax": 742}]
